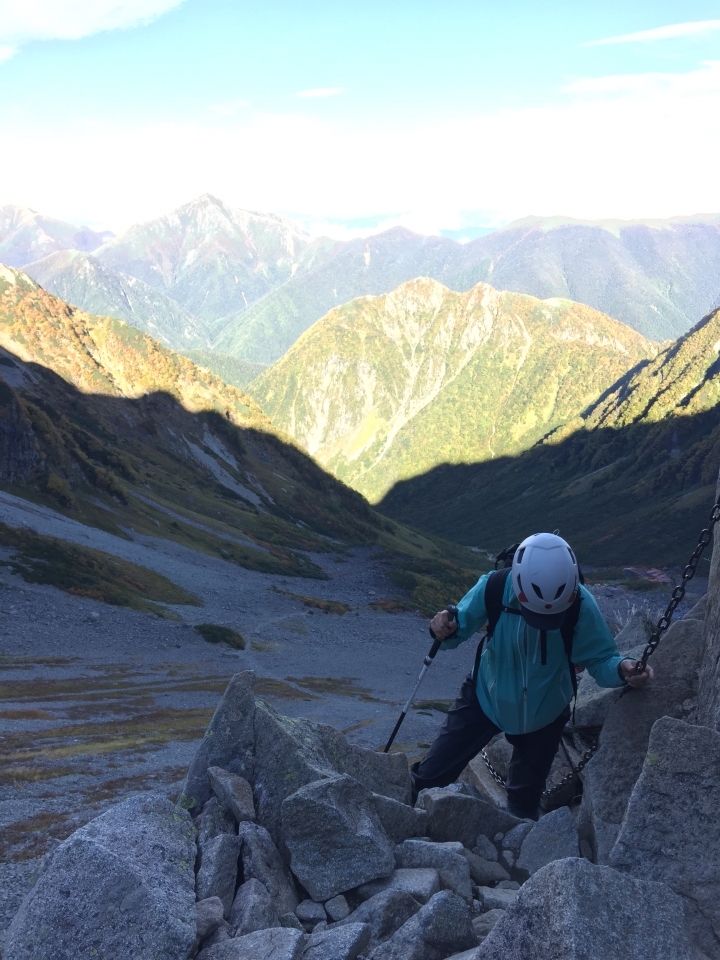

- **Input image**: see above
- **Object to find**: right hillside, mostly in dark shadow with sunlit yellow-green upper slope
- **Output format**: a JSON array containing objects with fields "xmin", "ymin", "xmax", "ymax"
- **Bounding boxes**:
[{"xmin": 379, "ymin": 302, "xmax": 720, "ymax": 573}]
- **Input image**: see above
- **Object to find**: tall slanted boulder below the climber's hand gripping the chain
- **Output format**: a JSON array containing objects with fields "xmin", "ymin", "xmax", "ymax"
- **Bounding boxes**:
[{"xmin": 578, "ymin": 620, "xmax": 703, "ymax": 863}]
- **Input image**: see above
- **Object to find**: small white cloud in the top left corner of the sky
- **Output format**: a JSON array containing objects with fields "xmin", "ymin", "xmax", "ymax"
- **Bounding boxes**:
[{"xmin": 0, "ymin": 0, "xmax": 183, "ymax": 59}]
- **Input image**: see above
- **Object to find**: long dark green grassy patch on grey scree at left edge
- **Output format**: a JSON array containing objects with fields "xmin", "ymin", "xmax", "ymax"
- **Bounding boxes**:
[{"xmin": 0, "ymin": 523, "xmax": 202, "ymax": 617}]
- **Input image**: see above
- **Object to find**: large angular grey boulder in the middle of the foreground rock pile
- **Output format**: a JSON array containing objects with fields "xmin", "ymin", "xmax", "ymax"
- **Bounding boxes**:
[{"xmin": 282, "ymin": 776, "xmax": 395, "ymax": 900}]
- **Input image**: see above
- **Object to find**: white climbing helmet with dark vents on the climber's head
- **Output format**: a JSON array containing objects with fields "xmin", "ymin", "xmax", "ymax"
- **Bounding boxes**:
[{"xmin": 512, "ymin": 533, "xmax": 578, "ymax": 630}]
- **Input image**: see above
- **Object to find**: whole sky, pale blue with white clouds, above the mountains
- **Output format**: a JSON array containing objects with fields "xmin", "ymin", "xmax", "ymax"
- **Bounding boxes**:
[{"xmin": 0, "ymin": 0, "xmax": 720, "ymax": 237}]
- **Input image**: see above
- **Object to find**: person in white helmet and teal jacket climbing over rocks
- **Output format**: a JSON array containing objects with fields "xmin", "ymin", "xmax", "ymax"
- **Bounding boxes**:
[{"xmin": 411, "ymin": 533, "xmax": 654, "ymax": 820}]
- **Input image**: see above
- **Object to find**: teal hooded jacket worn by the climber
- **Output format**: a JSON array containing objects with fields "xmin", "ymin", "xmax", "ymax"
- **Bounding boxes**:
[{"xmin": 440, "ymin": 573, "xmax": 624, "ymax": 733}]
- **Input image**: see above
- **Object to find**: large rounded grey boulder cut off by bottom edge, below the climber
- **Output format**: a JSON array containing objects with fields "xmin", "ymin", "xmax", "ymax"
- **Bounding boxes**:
[{"xmin": 476, "ymin": 859, "xmax": 695, "ymax": 960}]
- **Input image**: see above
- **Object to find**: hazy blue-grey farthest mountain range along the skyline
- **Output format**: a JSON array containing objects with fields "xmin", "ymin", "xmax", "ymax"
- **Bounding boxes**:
[{"xmin": 12, "ymin": 194, "xmax": 720, "ymax": 364}]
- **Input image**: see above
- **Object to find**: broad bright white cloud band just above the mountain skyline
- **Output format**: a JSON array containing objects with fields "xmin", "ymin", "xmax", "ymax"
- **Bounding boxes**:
[{"xmin": 5, "ymin": 62, "xmax": 720, "ymax": 237}]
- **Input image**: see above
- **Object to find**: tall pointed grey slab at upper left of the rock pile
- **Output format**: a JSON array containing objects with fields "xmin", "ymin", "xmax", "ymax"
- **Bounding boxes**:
[{"xmin": 180, "ymin": 670, "xmax": 255, "ymax": 814}]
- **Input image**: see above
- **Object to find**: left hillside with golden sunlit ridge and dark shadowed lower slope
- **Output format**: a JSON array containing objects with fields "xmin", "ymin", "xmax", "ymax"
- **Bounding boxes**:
[{"xmin": 0, "ymin": 267, "xmax": 484, "ymax": 603}]
